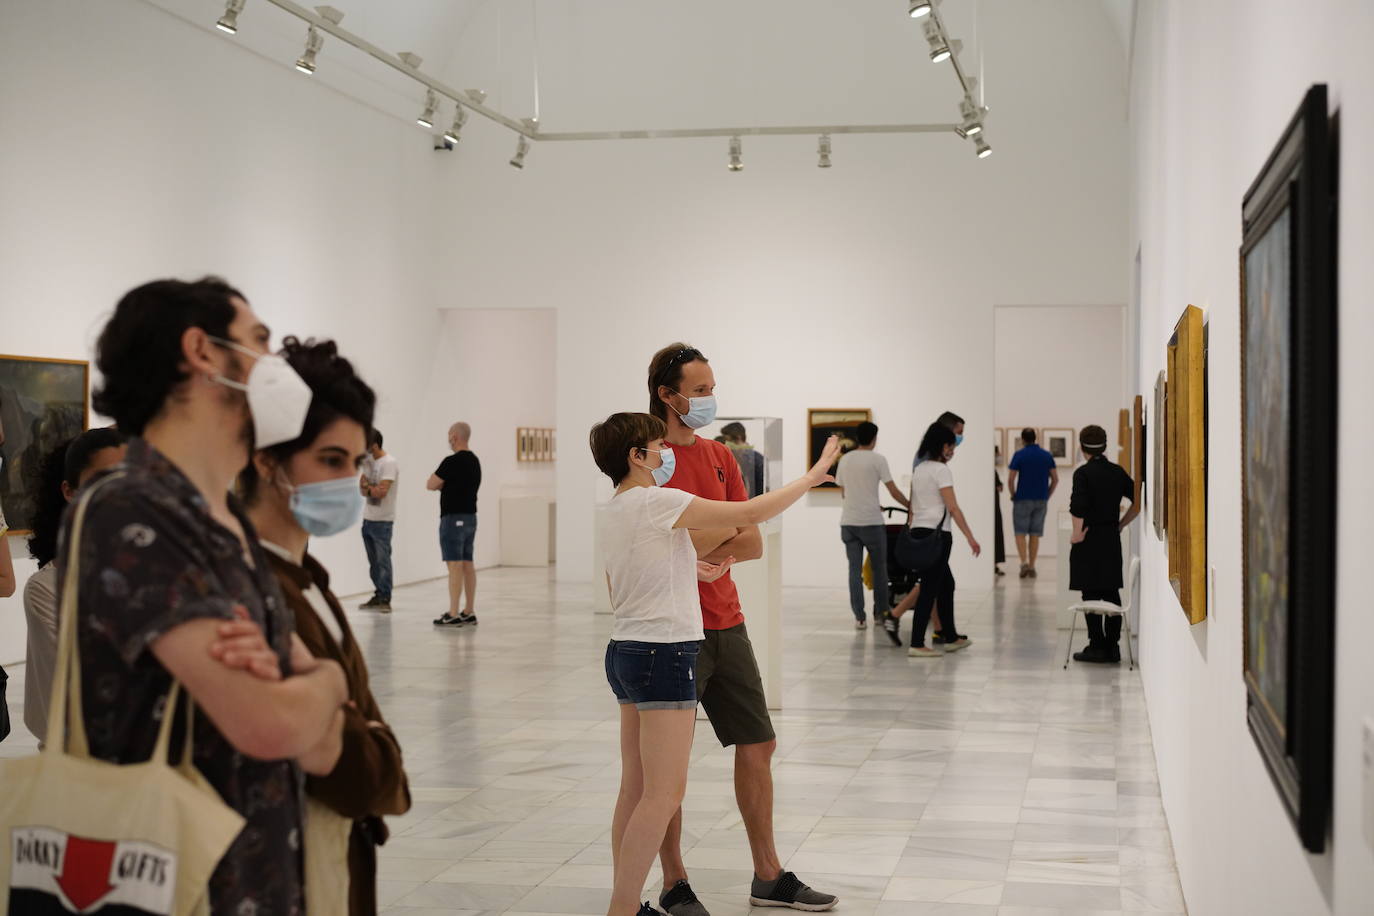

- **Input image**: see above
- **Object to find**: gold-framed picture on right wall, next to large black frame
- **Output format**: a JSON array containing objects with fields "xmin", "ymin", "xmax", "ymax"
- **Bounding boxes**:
[{"xmin": 1167, "ymin": 305, "xmax": 1206, "ymax": 623}]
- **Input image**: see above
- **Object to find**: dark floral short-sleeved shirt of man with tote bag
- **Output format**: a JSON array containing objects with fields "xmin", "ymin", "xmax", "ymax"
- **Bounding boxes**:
[{"xmin": 56, "ymin": 438, "xmax": 305, "ymax": 916}]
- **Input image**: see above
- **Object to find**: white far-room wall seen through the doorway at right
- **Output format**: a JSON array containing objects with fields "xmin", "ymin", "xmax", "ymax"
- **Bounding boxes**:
[{"xmin": 993, "ymin": 305, "xmax": 1127, "ymax": 560}]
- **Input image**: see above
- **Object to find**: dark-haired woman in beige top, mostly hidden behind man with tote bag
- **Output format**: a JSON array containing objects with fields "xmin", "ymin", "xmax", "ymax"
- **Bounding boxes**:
[{"xmin": 23, "ymin": 428, "xmax": 125, "ymax": 746}]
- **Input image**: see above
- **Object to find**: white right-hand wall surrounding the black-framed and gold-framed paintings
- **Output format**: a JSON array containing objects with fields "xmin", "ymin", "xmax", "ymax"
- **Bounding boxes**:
[{"xmin": 1131, "ymin": 0, "xmax": 1374, "ymax": 916}]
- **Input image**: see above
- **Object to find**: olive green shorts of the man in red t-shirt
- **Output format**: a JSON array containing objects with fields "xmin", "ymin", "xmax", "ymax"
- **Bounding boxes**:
[{"xmin": 697, "ymin": 623, "xmax": 776, "ymax": 747}]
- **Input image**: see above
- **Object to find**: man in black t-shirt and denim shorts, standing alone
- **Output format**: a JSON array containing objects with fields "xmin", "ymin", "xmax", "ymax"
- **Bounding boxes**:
[{"xmin": 425, "ymin": 423, "xmax": 482, "ymax": 626}]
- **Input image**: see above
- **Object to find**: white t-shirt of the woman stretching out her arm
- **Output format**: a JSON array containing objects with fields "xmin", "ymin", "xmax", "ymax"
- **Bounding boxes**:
[{"xmin": 602, "ymin": 486, "xmax": 705, "ymax": 643}]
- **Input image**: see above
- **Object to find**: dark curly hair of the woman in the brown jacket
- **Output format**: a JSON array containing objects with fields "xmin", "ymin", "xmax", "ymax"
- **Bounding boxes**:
[{"xmin": 239, "ymin": 336, "xmax": 376, "ymax": 505}]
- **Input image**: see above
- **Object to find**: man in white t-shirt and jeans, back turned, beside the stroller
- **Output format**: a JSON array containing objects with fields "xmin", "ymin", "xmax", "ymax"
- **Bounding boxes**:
[{"xmin": 835, "ymin": 422, "xmax": 911, "ymax": 630}]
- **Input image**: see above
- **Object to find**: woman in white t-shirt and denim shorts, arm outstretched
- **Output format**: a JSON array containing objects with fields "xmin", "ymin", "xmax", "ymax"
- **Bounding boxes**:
[{"xmin": 591, "ymin": 413, "xmax": 840, "ymax": 916}]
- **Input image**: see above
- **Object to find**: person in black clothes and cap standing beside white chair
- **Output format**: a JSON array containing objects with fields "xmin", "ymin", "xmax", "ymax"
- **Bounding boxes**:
[{"xmin": 1069, "ymin": 424, "xmax": 1139, "ymax": 663}]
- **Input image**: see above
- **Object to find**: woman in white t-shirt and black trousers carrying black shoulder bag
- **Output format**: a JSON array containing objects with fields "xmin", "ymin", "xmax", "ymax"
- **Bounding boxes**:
[{"xmin": 882, "ymin": 423, "xmax": 982, "ymax": 658}]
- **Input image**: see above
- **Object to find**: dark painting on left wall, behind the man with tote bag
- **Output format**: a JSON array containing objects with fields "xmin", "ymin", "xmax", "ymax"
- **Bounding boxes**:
[{"xmin": 0, "ymin": 356, "xmax": 91, "ymax": 534}]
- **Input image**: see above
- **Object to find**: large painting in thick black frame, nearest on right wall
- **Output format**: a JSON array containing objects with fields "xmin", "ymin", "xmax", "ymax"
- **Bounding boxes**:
[{"xmin": 1241, "ymin": 85, "xmax": 1335, "ymax": 853}]
